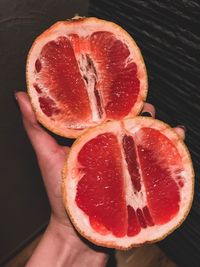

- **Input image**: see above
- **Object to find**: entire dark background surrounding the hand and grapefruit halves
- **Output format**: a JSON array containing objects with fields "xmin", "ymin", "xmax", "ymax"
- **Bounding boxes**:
[{"xmin": 0, "ymin": 0, "xmax": 200, "ymax": 267}]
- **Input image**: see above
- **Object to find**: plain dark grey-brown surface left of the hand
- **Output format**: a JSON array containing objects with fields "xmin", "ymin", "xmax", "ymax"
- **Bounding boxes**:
[{"xmin": 0, "ymin": 0, "xmax": 88, "ymax": 265}]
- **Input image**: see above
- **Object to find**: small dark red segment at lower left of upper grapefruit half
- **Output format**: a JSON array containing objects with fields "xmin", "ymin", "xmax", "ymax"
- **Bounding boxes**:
[{"xmin": 39, "ymin": 96, "xmax": 60, "ymax": 117}]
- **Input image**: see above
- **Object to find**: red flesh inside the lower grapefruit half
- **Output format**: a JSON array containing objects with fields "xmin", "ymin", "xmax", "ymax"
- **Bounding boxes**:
[{"xmin": 76, "ymin": 128, "xmax": 184, "ymax": 237}]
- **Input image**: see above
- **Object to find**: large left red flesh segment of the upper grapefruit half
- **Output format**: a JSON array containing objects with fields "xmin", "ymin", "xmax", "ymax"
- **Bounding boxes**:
[{"xmin": 39, "ymin": 37, "xmax": 91, "ymax": 121}]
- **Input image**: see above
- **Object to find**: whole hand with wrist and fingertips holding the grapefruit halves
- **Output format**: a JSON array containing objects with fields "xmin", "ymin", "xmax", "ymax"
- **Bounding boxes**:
[{"xmin": 15, "ymin": 92, "xmax": 185, "ymax": 267}]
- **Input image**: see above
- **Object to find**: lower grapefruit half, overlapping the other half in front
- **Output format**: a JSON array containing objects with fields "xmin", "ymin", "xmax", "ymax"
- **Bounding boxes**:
[{"xmin": 62, "ymin": 117, "xmax": 194, "ymax": 249}]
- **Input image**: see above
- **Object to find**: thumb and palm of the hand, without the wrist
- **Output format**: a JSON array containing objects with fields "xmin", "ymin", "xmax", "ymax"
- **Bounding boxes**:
[{"xmin": 16, "ymin": 92, "xmax": 74, "ymax": 230}]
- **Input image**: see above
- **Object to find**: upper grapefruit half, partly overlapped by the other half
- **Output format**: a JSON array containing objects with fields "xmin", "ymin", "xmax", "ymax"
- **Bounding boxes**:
[{"xmin": 27, "ymin": 18, "xmax": 147, "ymax": 137}]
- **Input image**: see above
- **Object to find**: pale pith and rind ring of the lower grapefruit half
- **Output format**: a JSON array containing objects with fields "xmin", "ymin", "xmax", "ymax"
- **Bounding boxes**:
[{"xmin": 63, "ymin": 117, "xmax": 194, "ymax": 248}]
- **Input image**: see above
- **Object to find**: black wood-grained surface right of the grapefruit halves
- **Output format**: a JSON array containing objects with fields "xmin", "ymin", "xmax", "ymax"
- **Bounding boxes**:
[{"xmin": 89, "ymin": 0, "xmax": 200, "ymax": 267}]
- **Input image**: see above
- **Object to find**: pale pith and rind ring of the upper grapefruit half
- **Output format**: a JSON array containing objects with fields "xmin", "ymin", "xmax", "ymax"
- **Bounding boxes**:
[{"xmin": 27, "ymin": 18, "xmax": 147, "ymax": 135}]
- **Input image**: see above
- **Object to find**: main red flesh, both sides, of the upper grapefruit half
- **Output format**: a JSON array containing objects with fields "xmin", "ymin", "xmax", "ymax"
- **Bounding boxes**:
[{"xmin": 35, "ymin": 31, "xmax": 140, "ymax": 122}]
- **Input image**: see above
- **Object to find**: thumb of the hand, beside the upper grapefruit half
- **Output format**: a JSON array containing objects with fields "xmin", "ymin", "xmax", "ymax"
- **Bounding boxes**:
[{"xmin": 15, "ymin": 92, "xmax": 60, "ymax": 159}]
